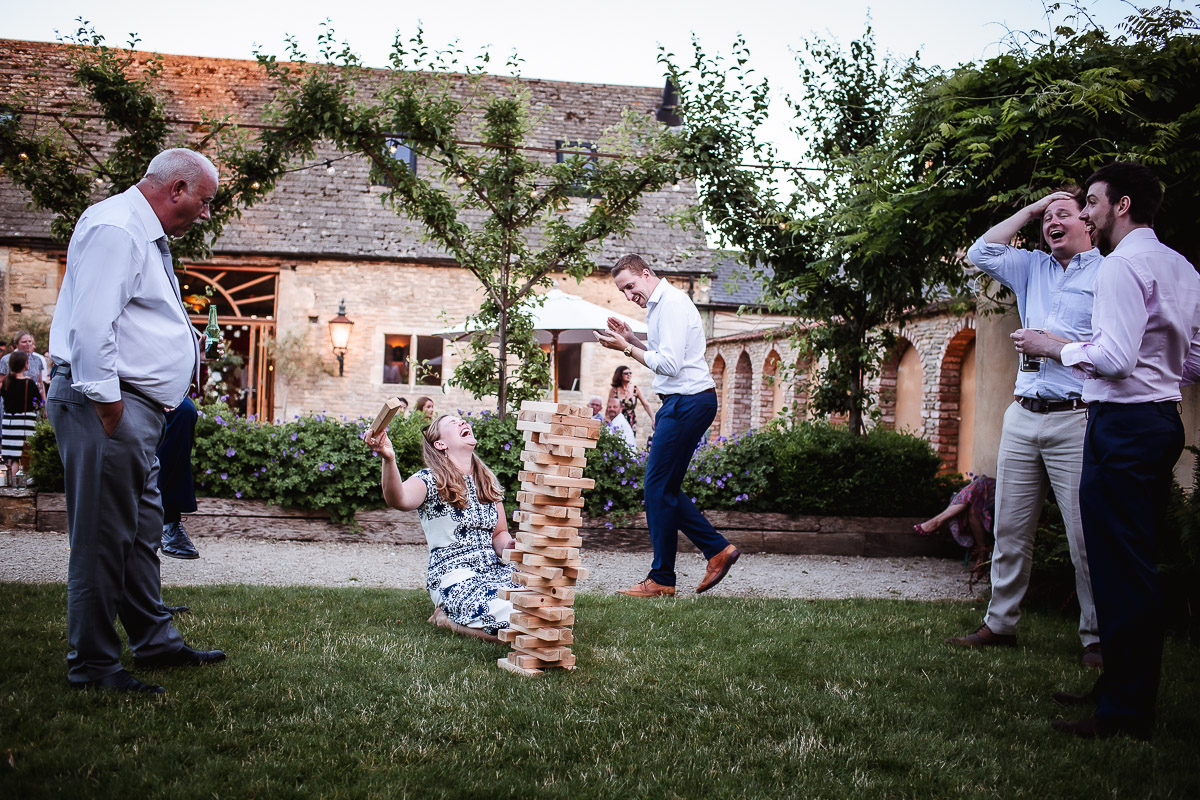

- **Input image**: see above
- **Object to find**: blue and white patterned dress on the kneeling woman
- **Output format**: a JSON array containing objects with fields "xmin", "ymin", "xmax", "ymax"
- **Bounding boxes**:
[{"xmin": 416, "ymin": 469, "xmax": 516, "ymax": 636}]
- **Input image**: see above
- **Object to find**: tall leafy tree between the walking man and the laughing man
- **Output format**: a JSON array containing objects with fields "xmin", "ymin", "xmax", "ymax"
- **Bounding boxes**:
[{"xmin": 661, "ymin": 29, "xmax": 961, "ymax": 433}]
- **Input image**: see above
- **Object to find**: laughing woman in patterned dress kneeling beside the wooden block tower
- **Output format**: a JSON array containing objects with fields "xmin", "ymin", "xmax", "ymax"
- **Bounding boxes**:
[{"xmin": 366, "ymin": 414, "xmax": 516, "ymax": 642}]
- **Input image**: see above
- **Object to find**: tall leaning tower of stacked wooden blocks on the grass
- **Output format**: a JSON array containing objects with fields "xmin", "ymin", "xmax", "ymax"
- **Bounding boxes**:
[{"xmin": 499, "ymin": 402, "xmax": 604, "ymax": 675}]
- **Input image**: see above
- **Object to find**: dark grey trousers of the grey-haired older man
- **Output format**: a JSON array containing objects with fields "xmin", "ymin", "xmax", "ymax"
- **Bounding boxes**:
[{"xmin": 46, "ymin": 375, "xmax": 184, "ymax": 682}]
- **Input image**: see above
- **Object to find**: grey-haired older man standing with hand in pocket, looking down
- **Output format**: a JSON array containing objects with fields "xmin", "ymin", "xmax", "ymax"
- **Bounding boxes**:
[{"xmin": 47, "ymin": 149, "xmax": 224, "ymax": 694}]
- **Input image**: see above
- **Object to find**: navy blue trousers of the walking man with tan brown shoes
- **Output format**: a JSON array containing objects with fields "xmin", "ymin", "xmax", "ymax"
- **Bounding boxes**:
[{"xmin": 644, "ymin": 392, "xmax": 730, "ymax": 587}]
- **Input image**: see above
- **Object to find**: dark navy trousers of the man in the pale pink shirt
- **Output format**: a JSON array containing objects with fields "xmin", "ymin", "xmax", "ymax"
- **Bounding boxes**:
[{"xmin": 1079, "ymin": 402, "xmax": 1183, "ymax": 736}]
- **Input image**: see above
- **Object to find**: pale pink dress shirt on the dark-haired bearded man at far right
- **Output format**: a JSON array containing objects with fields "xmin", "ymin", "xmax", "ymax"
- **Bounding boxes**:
[{"xmin": 1061, "ymin": 228, "xmax": 1200, "ymax": 403}]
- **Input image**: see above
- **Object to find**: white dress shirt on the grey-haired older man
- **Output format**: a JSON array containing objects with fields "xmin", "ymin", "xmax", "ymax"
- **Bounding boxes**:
[{"xmin": 50, "ymin": 186, "xmax": 199, "ymax": 408}]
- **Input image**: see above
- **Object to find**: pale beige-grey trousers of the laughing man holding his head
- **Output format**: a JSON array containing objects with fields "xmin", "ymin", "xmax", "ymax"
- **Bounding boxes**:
[{"xmin": 984, "ymin": 403, "xmax": 1100, "ymax": 646}]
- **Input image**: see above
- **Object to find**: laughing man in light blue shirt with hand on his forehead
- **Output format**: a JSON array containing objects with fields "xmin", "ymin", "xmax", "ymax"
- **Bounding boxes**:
[{"xmin": 946, "ymin": 192, "xmax": 1104, "ymax": 668}]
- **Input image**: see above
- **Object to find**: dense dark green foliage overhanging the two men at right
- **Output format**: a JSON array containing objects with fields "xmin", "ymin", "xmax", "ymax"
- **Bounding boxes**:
[{"xmin": 902, "ymin": 4, "xmax": 1200, "ymax": 265}]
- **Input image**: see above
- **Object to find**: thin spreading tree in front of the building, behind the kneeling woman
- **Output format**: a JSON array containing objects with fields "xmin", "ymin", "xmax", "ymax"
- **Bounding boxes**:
[{"xmin": 250, "ymin": 26, "xmax": 677, "ymax": 414}]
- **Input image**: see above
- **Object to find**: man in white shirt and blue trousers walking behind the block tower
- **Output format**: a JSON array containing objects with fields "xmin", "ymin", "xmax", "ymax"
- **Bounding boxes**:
[{"xmin": 596, "ymin": 254, "xmax": 742, "ymax": 597}]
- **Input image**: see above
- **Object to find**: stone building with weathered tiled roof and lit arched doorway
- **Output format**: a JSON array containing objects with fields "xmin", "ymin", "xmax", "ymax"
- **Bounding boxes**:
[{"xmin": 0, "ymin": 40, "xmax": 712, "ymax": 438}]
